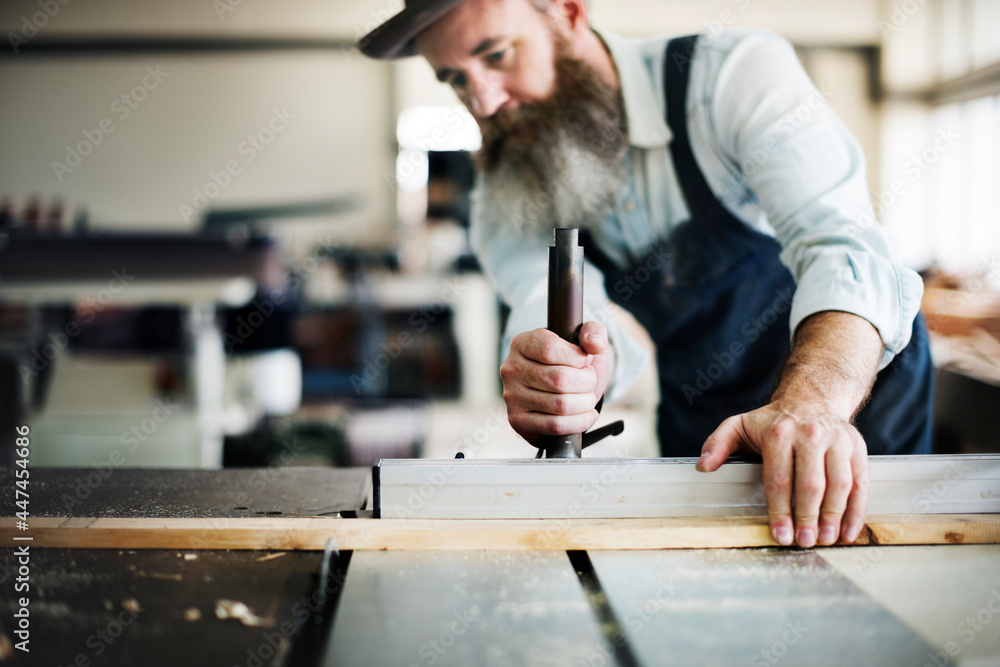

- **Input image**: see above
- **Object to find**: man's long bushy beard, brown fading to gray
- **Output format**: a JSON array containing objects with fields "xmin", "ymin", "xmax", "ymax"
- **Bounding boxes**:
[{"xmin": 476, "ymin": 33, "xmax": 628, "ymax": 238}]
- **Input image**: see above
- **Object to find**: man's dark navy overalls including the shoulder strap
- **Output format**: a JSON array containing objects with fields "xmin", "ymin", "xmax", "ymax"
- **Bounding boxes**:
[{"xmin": 582, "ymin": 36, "xmax": 934, "ymax": 456}]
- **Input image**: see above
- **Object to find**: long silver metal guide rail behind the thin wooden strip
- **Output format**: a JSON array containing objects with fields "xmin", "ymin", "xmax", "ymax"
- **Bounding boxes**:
[{"xmin": 372, "ymin": 454, "xmax": 1000, "ymax": 519}]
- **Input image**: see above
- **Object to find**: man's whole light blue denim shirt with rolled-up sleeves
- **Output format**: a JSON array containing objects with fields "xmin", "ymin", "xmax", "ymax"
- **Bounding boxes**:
[{"xmin": 472, "ymin": 31, "xmax": 923, "ymax": 400}]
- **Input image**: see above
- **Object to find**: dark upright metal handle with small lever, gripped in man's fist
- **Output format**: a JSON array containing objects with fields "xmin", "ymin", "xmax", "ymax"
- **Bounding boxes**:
[{"xmin": 535, "ymin": 227, "xmax": 625, "ymax": 459}]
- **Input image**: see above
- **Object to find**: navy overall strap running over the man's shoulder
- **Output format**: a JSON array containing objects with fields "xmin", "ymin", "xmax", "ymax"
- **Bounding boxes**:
[{"xmin": 663, "ymin": 35, "xmax": 730, "ymax": 220}]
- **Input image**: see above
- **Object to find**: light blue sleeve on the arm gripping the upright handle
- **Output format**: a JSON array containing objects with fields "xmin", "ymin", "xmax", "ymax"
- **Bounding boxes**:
[{"xmin": 470, "ymin": 195, "xmax": 649, "ymax": 402}]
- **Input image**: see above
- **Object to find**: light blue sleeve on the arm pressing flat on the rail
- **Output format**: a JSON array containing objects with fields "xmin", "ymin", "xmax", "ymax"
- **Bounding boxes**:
[{"xmin": 709, "ymin": 32, "xmax": 923, "ymax": 369}]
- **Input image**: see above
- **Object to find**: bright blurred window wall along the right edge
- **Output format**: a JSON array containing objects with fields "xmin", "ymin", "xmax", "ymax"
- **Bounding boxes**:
[{"xmin": 880, "ymin": 0, "xmax": 1000, "ymax": 280}]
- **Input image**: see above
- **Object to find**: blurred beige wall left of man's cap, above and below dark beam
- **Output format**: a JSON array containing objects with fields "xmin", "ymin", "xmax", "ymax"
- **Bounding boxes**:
[{"xmin": 0, "ymin": 0, "xmax": 396, "ymax": 246}]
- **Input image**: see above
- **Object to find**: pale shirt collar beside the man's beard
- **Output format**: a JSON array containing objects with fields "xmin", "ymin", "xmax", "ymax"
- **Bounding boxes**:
[{"xmin": 592, "ymin": 28, "xmax": 673, "ymax": 148}]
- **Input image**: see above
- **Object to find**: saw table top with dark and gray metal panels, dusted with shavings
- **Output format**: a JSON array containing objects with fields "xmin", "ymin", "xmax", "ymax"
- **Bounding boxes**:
[{"xmin": 0, "ymin": 468, "xmax": 1000, "ymax": 667}]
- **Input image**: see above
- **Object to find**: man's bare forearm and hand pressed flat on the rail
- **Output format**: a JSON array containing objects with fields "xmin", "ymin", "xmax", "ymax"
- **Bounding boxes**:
[{"xmin": 697, "ymin": 311, "xmax": 883, "ymax": 547}]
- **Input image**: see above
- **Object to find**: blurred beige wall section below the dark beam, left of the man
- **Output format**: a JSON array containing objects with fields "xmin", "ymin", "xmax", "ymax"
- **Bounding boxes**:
[{"xmin": 0, "ymin": 52, "xmax": 391, "ymax": 235}]
